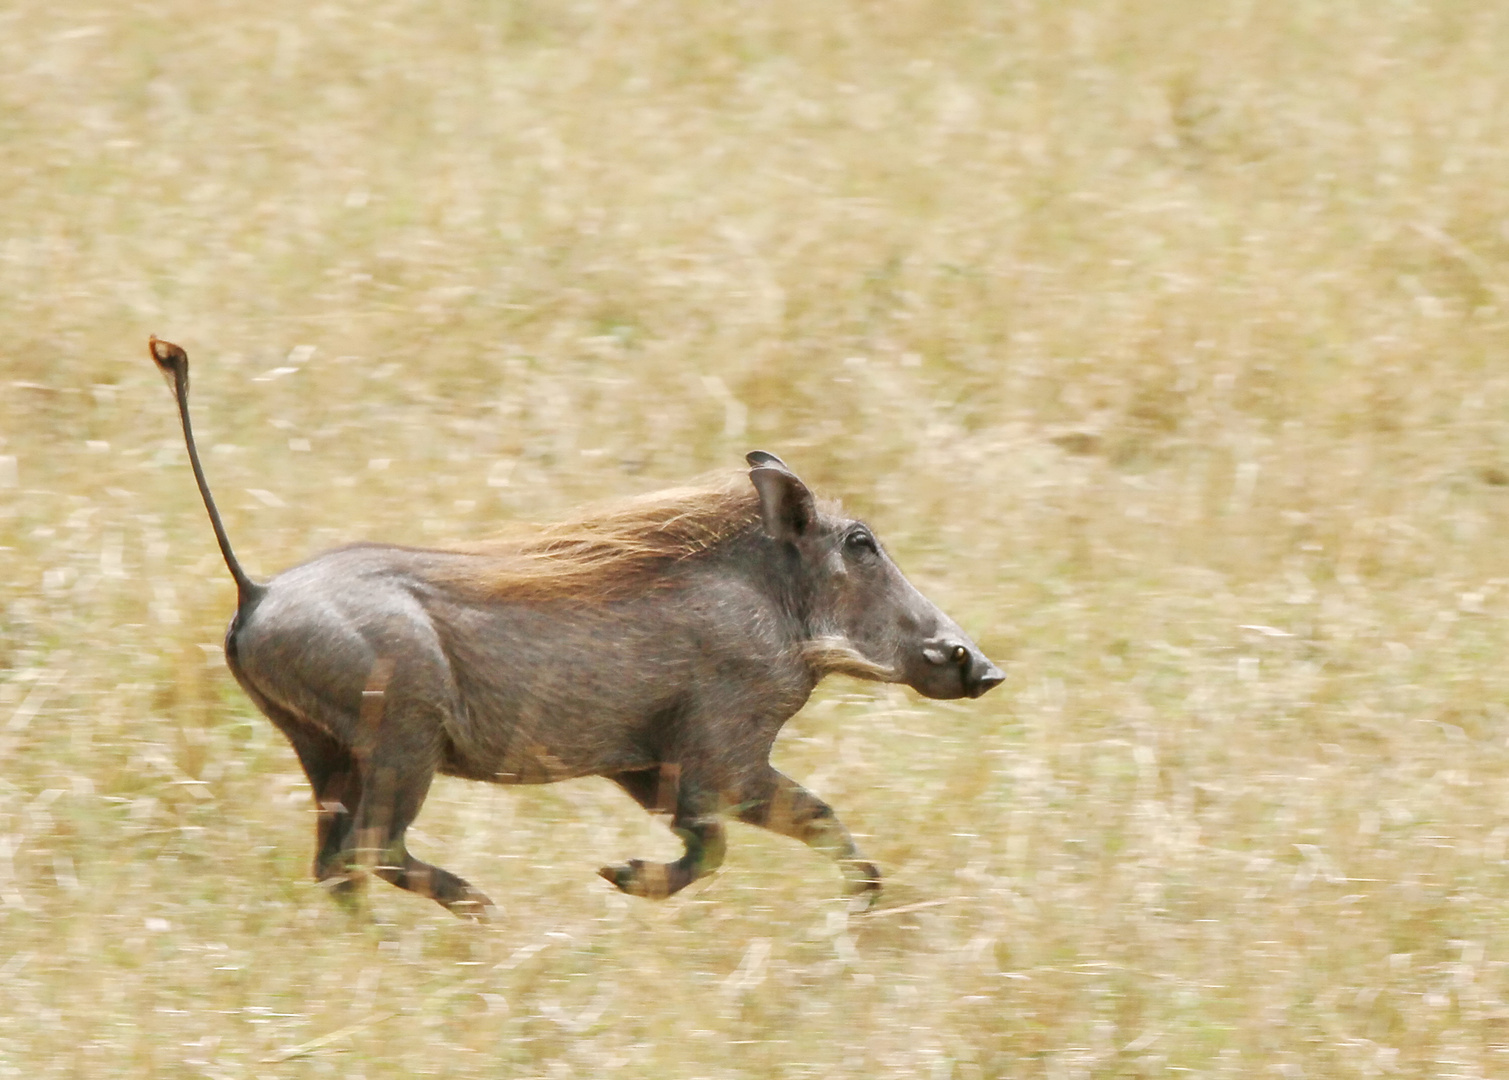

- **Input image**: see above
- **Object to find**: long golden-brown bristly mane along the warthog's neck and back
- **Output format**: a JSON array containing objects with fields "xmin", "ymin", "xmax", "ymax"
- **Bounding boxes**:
[{"xmin": 438, "ymin": 472, "xmax": 761, "ymax": 603}]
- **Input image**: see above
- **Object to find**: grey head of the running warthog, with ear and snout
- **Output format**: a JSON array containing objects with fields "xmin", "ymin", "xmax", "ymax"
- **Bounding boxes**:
[{"xmin": 747, "ymin": 451, "xmax": 1005, "ymax": 698}]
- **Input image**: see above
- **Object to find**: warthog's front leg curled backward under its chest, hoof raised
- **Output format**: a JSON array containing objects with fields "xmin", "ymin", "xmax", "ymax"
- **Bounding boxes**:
[{"xmin": 598, "ymin": 765, "xmax": 726, "ymax": 901}]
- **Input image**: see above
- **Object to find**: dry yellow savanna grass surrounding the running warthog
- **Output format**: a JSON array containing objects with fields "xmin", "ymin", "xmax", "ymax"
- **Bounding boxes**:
[{"xmin": 0, "ymin": 0, "xmax": 1509, "ymax": 1080}]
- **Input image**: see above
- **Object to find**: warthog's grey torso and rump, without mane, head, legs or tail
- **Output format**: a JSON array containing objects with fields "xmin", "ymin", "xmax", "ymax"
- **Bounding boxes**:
[{"xmin": 228, "ymin": 545, "xmax": 816, "ymax": 783}]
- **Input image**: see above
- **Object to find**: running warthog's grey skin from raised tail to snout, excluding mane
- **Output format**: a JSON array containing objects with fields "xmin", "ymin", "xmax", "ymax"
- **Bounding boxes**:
[{"xmin": 151, "ymin": 338, "xmax": 1005, "ymax": 920}]
